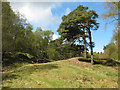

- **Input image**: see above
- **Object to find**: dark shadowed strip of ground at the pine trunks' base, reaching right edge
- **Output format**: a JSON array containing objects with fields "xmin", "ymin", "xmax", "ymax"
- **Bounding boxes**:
[{"xmin": 78, "ymin": 58, "xmax": 120, "ymax": 66}]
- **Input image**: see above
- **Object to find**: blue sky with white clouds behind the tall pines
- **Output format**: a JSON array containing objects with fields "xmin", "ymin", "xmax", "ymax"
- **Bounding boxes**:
[{"xmin": 10, "ymin": 2, "xmax": 115, "ymax": 52}]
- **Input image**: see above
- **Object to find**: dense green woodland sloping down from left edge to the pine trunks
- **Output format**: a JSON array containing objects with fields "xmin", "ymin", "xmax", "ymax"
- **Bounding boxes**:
[{"xmin": 2, "ymin": 2, "xmax": 84, "ymax": 60}]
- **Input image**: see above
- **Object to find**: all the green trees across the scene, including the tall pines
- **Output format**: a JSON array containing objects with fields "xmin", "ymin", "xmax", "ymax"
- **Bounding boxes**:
[{"xmin": 2, "ymin": 2, "xmax": 119, "ymax": 65}]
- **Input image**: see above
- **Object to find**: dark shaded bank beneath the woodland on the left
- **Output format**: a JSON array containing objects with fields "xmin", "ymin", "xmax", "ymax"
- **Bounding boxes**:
[{"xmin": 2, "ymin": 53, "xmax": 51, "ymax": 68}]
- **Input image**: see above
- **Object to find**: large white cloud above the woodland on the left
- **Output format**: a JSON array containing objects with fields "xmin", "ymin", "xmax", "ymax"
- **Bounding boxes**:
[{"xmin": 11, "ymin": 2, "xmax": 60, "ymax": 28}]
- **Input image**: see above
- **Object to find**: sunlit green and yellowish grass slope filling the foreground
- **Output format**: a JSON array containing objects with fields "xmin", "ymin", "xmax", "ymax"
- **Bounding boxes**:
[{"xmin": 2, "ymin": 60, "xmax": 118, "ymax": 88}]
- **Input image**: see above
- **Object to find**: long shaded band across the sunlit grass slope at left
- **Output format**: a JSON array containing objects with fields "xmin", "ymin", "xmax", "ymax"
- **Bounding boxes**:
[{"xmin": 2, "ymin": 64, "xmax": 59, "ymax": 83}]
